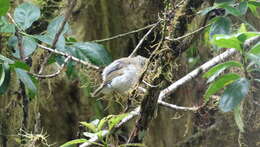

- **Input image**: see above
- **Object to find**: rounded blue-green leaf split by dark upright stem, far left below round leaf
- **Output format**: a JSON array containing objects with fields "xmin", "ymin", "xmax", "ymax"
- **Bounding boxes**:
[{"xmin": 8, "ymin": 36, "xmax": 37, "ymax": 59}]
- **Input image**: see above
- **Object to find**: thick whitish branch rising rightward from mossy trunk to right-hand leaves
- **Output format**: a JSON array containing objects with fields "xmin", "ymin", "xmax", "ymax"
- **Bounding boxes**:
[{"xmin": 158, "ymin": 48, "xmax": 236, "ymax": 105}]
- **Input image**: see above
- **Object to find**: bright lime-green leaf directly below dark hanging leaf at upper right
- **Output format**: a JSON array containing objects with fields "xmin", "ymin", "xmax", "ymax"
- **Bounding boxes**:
[{"xmin": 211, "ymin": 35, "xmax": 242, "ymax": 51}]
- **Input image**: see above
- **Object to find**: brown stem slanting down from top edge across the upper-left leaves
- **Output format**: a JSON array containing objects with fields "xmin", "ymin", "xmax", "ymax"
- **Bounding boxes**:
[{"xmin": 38, "ymin": 0, "xmax": 77, "ymax": 74}]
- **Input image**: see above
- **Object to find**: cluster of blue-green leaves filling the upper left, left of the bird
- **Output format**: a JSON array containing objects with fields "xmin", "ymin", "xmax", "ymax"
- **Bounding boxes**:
[{"xmin": 0, "ymin": 1, "xmax": 112, "ymax": 99}]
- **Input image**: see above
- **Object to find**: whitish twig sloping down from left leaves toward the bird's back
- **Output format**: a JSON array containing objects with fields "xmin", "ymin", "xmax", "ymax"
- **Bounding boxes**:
[{"xmin": 38, "ymin": 44, "xmax": 99, "ymax": 69}]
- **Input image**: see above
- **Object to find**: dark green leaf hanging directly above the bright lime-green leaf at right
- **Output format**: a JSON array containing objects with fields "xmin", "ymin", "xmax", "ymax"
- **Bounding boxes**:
[{"xmin": 209, "ymin": 17, "xmax": 231, "ymax": 38}]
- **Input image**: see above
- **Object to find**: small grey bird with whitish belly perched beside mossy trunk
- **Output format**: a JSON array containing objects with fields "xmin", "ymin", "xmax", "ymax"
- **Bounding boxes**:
[{"xmin": 92, "ymin": 56, "xmax": 148, "ymax": 97}]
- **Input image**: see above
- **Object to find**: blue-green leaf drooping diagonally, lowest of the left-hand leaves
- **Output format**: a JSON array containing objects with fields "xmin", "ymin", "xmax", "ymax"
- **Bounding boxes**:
[{"xmin": 15, "ymin": 68, "xmax": 37, "ymax": 94}]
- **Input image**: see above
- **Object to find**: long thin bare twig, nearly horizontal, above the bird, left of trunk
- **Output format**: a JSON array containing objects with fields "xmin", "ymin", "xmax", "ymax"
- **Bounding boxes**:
[{"xmin": 91, "ymin": 23, "xmax": 157, "ymax": 43}]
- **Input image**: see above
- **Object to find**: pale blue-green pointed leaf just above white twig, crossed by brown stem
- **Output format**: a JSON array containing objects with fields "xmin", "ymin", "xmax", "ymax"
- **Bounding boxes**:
[{"xmin": 34, "ymin": 33, "xmax": 65, "ymax": 51}]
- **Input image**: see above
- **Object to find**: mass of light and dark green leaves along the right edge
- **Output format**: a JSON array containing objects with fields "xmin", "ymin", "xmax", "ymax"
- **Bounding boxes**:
[{"xmin": 199, "ymin": 0, "xmax": 260, "ymax": 131}]
